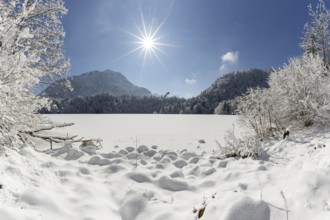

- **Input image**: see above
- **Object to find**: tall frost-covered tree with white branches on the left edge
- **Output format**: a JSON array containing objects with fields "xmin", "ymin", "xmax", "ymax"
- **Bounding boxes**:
[{"xmin": 0, "ymin": 0, "xmax": 69, "ymax": 146}]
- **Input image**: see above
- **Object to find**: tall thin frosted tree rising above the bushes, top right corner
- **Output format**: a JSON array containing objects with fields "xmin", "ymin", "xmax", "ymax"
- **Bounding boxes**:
[{"xmin": 300, "ymin": 0, "xmax": 330, "ymax": 66}]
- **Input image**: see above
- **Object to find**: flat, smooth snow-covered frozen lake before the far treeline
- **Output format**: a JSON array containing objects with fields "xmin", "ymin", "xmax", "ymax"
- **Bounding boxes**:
[{"xmin": 47, "ymin": 114, "xmax": 240, "ymax": 151}]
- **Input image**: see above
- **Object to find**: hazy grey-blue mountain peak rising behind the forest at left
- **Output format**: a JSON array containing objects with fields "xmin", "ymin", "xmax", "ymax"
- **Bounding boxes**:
[{"xmin": 41, "ymin": 70, "xmax": 151, "ymax": 98}]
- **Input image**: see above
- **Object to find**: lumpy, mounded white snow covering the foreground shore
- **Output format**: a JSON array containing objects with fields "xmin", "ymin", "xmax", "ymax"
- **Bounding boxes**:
[{"xmin": 0, "ymin": 116, "xmax": 330, "ymax": 220}]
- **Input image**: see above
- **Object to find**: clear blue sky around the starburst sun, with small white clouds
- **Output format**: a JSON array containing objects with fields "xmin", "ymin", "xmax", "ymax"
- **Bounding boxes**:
[{"xmin": 63, "ymin": 0, "xmax": 320, "ymax": 97}]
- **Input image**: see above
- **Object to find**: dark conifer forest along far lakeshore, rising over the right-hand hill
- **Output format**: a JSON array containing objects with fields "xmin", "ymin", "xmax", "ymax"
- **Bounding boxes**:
[{"xmin": 41, "ymin": 69, "xmax": 269, "ymax": 114}]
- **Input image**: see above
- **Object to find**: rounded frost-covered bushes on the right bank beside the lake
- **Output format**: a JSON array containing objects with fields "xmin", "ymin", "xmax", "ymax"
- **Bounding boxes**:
[{"xmin": 237, "ymin": 54, "xmax": 330, "ymax": 138}]
